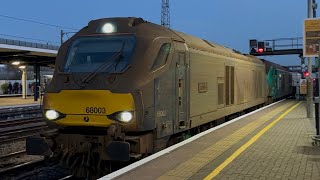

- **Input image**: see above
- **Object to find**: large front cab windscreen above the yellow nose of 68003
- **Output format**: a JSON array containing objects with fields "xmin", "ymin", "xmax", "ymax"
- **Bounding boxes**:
[{"xmin": 64, "ymin": 35, "xmax": 136, "ymax": 73}]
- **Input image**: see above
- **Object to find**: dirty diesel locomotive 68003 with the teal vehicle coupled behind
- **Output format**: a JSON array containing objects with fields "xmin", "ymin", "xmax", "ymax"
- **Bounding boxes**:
[{"xmin": 27, "ymin": 17, "xmax": 291, "ymax": 177}]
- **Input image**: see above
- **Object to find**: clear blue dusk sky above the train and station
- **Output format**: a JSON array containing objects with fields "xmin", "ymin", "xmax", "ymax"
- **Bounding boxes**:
[{"xmin": 0, "ymin": 0, "xmax": 314, "ymax": 65}]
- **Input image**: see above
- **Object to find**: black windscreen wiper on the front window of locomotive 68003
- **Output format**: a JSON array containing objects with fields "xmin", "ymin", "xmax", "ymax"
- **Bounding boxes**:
[{"xmin": 81, "ymin": 41, "xmax": 126, "ymax": 84}]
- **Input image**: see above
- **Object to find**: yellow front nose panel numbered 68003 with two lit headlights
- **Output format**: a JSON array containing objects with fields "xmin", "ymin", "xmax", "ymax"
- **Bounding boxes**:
[{"xmin": 43, "ymin": 90, "xmax": 134, "ymax": 127}]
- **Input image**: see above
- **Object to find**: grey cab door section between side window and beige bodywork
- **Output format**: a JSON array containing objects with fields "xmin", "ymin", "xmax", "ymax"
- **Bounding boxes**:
[{"xmin": 154, "ymin": 41, "xmax": 189, "ymax": 138}]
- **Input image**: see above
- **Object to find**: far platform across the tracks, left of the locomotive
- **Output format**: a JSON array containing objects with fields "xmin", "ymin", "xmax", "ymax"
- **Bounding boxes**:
[{"xmin": 0, "ymin": 96, "xmax": 40, "ymax": 108}]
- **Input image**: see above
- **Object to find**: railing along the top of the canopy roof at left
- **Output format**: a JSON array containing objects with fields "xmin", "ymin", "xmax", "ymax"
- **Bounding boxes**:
[{"xmin": 0, "ymin": 38, "xmax": 59, "ymax": 50}]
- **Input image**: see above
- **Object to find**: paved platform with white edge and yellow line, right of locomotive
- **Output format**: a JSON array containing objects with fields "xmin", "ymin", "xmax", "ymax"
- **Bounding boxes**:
[{"xmin": 101, "ymin": 100, "xmax": 320, "ymax": 180}]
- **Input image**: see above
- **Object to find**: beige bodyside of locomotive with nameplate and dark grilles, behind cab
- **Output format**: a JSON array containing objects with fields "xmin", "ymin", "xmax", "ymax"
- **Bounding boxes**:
[{"xmin": 190, "ymin": 50, "xmax": 265, "ymax": 127}]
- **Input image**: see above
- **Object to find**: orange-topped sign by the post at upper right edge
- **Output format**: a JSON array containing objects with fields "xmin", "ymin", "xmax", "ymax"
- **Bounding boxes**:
[{"xmin": 303, "ymin": 18, "xmax": 320, "ymax": 57}]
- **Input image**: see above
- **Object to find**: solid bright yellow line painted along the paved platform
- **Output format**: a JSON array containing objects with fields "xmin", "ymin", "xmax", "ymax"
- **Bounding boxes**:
[{"xmin": 204, "ymin": 102, "xmax": 301, "ymax": 180}]
